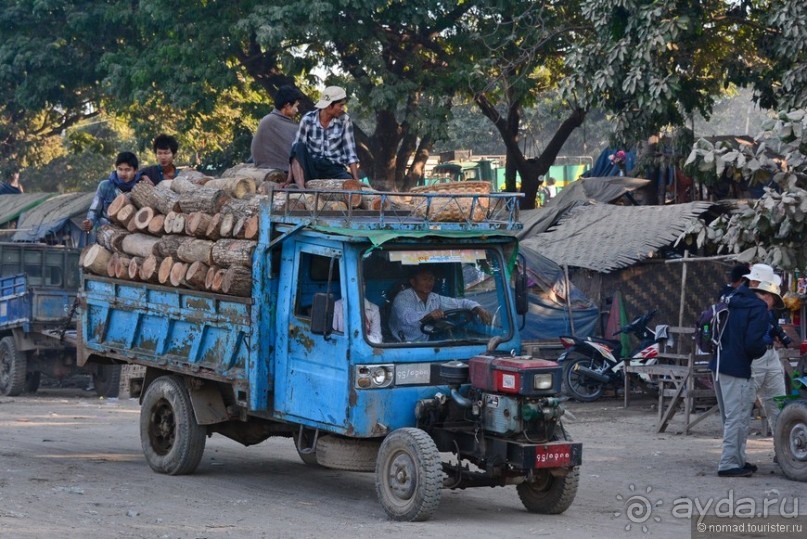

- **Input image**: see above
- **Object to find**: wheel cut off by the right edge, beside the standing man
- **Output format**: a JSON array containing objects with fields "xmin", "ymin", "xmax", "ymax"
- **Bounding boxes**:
[{"xmin": 773, "ymin": 400, "xmax": 807, "ymax": 481}]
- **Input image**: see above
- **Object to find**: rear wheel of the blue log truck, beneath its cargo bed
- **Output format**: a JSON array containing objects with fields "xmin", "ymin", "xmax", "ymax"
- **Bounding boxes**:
[{"xmin": 140, "ymin": 376, "xmax": 206, "ymax": 475}]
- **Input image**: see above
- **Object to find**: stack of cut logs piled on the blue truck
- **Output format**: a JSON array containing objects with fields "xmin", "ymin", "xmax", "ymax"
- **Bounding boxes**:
[{"xmin": 81, "ymin": 165, "xmax": 400, "ymax": 297}]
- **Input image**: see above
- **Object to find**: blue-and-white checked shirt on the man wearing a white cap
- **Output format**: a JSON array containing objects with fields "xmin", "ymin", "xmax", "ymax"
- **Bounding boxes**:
[{"xmin": 294, "ymin": 109, "xmax": 359, "ymax": 166}]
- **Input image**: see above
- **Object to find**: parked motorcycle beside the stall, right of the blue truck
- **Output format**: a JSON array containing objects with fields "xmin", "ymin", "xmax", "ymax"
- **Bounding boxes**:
[{"xmin": 558, "ymin": 309, "xmax": 666, "ymax": 402}]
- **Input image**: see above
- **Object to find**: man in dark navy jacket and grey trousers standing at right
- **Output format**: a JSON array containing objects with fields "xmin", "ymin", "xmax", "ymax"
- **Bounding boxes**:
[{"xmin": 709, "ymin": 285, "xmax": 768, "ymax": 477}]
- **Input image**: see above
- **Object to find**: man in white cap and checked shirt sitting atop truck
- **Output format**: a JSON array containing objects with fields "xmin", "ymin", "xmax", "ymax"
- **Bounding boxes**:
[{"xmin": 290, "ymin": 86, "xmax": 359, "ymax": 187}]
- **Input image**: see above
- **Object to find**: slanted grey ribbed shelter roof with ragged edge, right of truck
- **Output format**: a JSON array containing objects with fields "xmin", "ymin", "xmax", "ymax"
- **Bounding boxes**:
[{"xmin": 522, "ymin": 202, "xmax": 714, "ymax": 273}]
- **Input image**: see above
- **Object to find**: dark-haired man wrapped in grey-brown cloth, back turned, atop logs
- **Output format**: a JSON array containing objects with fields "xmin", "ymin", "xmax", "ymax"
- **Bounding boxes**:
[{"xmin": 250, "ymin": 84, "xmax": 303, "ymax": 183}]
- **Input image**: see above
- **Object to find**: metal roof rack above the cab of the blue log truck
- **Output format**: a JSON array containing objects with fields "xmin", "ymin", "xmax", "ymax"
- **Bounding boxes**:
[{"xmin": 264, "ymin": 189, "xmax": 524, "ymax": 231}]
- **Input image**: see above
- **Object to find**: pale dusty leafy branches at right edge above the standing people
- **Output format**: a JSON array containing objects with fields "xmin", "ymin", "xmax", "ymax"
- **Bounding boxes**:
[{"xmin": 685, "ymin": 109, "xmax": 807, "ymax": 269}]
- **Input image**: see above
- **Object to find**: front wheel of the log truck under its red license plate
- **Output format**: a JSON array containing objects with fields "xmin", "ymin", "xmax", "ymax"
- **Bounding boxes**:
[{"xmin": 516, "ymin": 433, "xmax": 580, "ymax": 515}]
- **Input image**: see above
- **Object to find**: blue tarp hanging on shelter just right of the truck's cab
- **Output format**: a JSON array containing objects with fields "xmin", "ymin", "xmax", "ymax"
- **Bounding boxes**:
[{"xmin": 520, "ymin": 245, "xmax": 600, "ymax": 341}]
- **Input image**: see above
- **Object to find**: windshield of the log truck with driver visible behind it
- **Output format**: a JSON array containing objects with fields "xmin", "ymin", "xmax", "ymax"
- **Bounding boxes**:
[{"xmin": 362, "ymin": 248, "xmax": 513, "ymax": 346}]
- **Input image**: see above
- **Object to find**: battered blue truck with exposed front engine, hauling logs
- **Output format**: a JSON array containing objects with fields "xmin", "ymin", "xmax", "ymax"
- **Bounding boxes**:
[{"xmin": 77, "ymin": 190, "xmax": 582, "ymax": 521}]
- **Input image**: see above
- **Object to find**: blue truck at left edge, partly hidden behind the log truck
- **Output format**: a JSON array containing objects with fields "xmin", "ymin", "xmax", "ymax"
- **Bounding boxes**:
[{"xmin": 0, "ymin": 242, "xmax": 120, "ymax": 397}]
